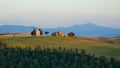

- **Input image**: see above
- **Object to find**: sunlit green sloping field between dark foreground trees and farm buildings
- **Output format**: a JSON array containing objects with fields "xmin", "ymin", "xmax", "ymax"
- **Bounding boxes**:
[{"xmin": 3, "ymin": 37, "xmax": 120, "ymax": 59}]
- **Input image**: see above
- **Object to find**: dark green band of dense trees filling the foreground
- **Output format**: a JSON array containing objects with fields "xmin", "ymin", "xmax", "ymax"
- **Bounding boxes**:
[{"xmin": 0, "ymin": 46, "xmax": 120, "ymax": 68}]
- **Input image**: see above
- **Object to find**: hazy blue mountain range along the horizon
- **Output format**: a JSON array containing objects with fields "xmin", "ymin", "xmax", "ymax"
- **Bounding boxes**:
[{"xmin": 0, "ymin": 23, "xmax": 120, "ymax": 37}]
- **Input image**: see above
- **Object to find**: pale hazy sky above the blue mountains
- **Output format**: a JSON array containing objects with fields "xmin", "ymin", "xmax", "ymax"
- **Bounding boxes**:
[{"xmin": 0, "ymin": 0, "xmax": 120, "ymax": 28}]
